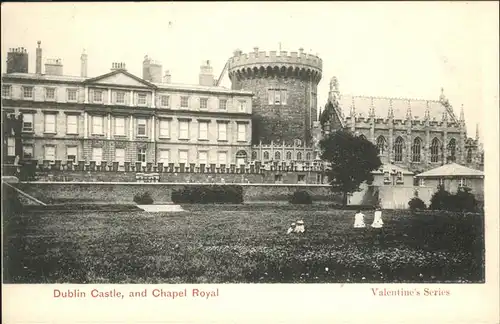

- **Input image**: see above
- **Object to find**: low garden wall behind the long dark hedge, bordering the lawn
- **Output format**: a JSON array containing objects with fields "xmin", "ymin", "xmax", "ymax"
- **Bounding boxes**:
[{"xmin": 16, "ymin": 182, "xmax": 336, "ymax": 204}]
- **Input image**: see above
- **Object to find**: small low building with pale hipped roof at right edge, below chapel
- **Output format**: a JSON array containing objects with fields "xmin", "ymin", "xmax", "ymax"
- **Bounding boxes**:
[{"xmin": 415, "ymin": 163, "xmax": 484, "ymax": 200}]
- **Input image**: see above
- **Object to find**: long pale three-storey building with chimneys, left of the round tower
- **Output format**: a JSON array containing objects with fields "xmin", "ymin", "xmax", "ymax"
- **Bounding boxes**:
[{"xmin": 2, "ymin": 42, "xmax": 253, "ymax": 171}]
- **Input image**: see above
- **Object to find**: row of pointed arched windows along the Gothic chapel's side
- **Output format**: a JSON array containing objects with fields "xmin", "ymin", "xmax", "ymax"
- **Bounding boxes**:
[{"xmin": 372, "ymin": 135, "xmax": 473, "ymax": 163}]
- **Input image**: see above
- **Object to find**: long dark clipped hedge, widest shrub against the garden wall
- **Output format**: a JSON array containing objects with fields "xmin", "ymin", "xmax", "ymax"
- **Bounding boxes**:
[{"xmin": 171, "ymin": 185, "xmax": 243, "ymax": 204}]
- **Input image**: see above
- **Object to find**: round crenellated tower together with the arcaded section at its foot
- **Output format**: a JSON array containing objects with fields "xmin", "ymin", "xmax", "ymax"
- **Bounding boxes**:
[{"xmin": 227, "ymin": 47, "xmax": 323, "ymax": 175}]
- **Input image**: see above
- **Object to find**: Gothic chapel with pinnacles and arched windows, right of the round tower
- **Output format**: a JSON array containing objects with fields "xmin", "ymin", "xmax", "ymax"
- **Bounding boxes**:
[{"xmin": 321, "ymin": 77, "xmax": 484, "ymax": 173}]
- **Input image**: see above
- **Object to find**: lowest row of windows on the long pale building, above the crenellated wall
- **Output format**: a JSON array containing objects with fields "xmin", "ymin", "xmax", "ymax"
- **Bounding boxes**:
[{"xmin": 23, "ymin": 145, "xmax": 232, "ymax": 165}]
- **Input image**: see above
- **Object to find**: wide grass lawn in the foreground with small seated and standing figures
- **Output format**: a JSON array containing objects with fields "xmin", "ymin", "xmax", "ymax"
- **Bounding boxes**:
[{"xmin": 4, "ymin": 205, "xmax": 484, "ymax": 283}]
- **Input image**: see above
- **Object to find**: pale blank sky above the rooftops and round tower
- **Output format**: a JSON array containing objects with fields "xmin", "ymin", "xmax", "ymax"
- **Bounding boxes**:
[{"xmin": 1, "ymin": 2, "xmax": 498, "ymax": 142}]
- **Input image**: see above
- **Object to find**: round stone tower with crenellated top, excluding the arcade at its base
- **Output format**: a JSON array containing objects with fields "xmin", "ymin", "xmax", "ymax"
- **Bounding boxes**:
[{"xmin": 228, "ymin": 48, "xmax": 323, "ymax": 145}]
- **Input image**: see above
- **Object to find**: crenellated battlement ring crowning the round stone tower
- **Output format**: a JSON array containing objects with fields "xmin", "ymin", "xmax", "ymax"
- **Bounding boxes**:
[{"xmin": 228, "ymin": 48, "xmax": 323, "ymax": 73}]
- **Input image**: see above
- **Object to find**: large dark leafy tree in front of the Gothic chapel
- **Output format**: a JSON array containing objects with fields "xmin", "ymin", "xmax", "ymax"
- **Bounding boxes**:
[{"xmin": 320, "ymin": 130, "xmax": 382, "ymax": 206}]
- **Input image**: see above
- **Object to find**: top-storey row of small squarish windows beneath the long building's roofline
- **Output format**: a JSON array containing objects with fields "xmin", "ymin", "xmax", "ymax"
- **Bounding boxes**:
[{"xmin": 2, "ymin": 85, "xmax": 246, "ymax": 112}]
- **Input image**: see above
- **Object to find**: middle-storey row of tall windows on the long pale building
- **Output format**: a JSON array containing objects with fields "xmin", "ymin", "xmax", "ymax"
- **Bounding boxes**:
[{"xmin": 23, "ymin": 113, "xmax": 247, "ymax": 141}]
